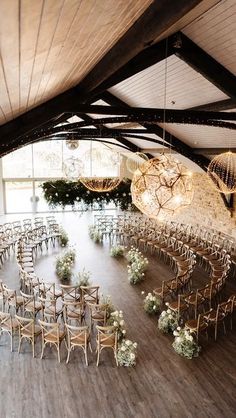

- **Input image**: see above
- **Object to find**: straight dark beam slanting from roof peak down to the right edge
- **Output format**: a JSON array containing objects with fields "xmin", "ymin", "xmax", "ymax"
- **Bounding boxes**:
[{"xmin": 173, "ymin": 32, "xmax": 236, "ymax": 101}]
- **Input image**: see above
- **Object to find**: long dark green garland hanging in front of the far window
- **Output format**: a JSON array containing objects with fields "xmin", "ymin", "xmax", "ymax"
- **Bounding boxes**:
[{"xmin": 41, "ymin": 179, "xmax": 137, "ymax": 210}]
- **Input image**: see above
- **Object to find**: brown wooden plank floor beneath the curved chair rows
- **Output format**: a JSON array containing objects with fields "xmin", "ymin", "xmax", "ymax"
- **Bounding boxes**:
[{"xmin": 0, "ymin": 213, "xmax": 236, "ymax": 418}]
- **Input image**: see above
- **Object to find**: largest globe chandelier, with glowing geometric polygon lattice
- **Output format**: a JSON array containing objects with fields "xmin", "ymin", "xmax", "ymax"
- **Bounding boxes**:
[{"xmin": 131, "ymin": 155, "xmax": 193, "ymax": 220}]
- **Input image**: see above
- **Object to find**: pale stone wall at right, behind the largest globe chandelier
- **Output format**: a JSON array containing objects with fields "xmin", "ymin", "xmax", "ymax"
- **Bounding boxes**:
[{"xmin": 173, "ymin": 173, "xmax": 236, "ymax": 239}]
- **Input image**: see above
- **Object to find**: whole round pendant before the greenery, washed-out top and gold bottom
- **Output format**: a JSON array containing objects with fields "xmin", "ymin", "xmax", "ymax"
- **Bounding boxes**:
[{"xmin": 80, "ymin": 141, "xmax": 121, "ymax": 193}]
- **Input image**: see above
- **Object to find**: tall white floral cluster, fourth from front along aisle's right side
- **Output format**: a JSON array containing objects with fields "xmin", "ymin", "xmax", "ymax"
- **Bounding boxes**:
[{"xmin": 126, "ymin": 247, "xmax": 148, "ymax": 284}]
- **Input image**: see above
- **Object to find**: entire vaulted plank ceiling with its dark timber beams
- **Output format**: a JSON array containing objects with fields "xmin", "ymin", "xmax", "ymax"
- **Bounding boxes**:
[{"xmin": 0, "ymin": 0, "xmax": 236, "ymax": 173}]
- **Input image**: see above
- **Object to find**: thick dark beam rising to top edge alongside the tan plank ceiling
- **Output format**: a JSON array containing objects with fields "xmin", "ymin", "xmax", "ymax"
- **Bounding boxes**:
[{"xmin": 76, "ymin": 0, "xmax": 204, "ymax": 98}]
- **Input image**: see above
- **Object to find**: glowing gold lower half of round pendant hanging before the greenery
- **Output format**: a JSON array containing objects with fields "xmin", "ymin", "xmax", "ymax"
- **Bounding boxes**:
[{"xmin": 80, "ymin": 177, "xmax": 121, "ymax": 193}]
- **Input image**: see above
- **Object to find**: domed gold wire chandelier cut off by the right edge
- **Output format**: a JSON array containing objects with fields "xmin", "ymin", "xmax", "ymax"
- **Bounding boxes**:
[{"xmin": 207, "ymin": 151, "xmax": 236, "ymax": 194}]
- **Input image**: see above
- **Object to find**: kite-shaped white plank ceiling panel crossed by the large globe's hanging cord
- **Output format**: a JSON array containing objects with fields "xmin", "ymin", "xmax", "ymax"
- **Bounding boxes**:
[{"xmin": 110, "ymin": 55, "xmax": 228, "ymax": 109}]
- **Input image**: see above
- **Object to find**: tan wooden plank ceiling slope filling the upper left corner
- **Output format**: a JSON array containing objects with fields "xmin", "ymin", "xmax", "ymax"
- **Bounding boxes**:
[{"xmin": 0, "ymin": 0, "xmax": 152, "ymax": 124}]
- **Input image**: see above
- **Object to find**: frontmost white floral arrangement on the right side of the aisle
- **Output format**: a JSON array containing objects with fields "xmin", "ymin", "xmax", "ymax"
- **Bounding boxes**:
[{"xmin": 172, "ymin": 327, "xmax": 201, "ymax": 359}]
